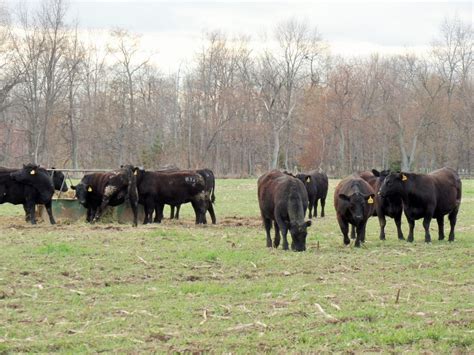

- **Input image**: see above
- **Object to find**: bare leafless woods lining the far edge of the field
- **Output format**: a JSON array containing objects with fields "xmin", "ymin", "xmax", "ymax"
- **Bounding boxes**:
[{"xmin": 0, "ymin": 0, "xmax": 474, "ymax": 176}]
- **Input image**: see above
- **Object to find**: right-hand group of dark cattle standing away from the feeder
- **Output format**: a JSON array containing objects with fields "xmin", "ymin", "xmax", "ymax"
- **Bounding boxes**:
[{"xmin": 258, "ymin": 168, "xmax": 461, "ymax": 251}]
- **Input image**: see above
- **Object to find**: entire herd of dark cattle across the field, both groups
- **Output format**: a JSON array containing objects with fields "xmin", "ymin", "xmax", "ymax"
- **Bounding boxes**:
[{"xmin": 0, "ymin": 164, "xmax": 461, "ymax": 251}]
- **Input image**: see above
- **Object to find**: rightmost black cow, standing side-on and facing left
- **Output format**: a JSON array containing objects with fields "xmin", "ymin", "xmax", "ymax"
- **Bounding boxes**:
[{"xmin": 379, "ymin": 168, "xmax": 462, "ymax": 243}]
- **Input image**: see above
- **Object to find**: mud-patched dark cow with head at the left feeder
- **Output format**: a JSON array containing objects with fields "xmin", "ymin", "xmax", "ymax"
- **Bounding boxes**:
[{"xmin": 71, "ymin": 165, "xmax": 138, "ymax": 227}]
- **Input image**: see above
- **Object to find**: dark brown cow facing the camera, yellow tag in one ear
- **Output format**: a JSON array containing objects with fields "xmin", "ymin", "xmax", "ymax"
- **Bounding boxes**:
[{"xmin": 334, "ymin": 174, "xmax": 375, "ymax": 247}]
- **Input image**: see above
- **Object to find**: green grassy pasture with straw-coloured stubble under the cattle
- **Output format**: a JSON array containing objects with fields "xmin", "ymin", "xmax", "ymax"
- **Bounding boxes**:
[{"xmin": 0, "ymin": 179, "xmax": 474, "ymax": 353}]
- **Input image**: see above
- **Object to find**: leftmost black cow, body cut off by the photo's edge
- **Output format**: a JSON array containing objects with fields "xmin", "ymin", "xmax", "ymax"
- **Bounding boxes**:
[{"xmin": 0, "ymin": 164, "xmax": 56, "ymax": 224}]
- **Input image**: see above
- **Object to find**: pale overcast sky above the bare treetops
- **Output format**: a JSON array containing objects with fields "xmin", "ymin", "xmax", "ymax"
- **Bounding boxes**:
[{"xmin": 8, "ymin": 0, "xmax": 473, "ymax": 71}]
